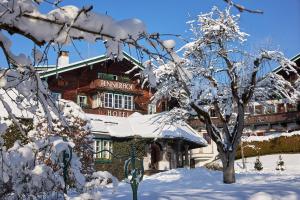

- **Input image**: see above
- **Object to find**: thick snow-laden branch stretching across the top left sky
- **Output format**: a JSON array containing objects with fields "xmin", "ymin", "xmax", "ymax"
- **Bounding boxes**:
[{"xmin": 0, "ymin": 0, "xmax": 146, "ymax": 59}]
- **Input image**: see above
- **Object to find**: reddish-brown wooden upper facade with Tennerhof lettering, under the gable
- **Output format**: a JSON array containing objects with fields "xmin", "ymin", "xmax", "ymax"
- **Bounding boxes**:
[{"xmin": 41, "ymin": 53, "xmax": 166, "ymax": 117}]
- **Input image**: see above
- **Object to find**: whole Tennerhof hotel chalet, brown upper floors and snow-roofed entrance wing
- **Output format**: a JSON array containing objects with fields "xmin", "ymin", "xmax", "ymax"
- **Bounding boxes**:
[{"xmin": 38, "ymin": 52, "xmax": 206, "ymax": 177}]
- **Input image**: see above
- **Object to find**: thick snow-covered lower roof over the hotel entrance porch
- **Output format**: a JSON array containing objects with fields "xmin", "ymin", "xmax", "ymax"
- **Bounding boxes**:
[{"xmin": 87, "ymin": 113, "xmax": 207, "ymax": 146}]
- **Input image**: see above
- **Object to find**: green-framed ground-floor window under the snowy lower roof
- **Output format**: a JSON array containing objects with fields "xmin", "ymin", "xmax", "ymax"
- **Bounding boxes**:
[{"xmin": 94, "ymin": 139, "xmax": 112, "ymax": 160}]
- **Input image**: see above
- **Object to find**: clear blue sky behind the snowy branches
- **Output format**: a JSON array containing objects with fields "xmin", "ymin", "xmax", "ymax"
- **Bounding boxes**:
[{"xmin": 0, "ymin": 0, "xmax": 300, "ymax": 66}]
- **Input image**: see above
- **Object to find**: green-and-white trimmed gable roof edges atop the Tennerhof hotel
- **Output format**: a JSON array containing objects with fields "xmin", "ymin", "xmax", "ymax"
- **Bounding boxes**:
[{"xmin": 37, "ymin": 52, "xmax": 143, "ymax": 78}]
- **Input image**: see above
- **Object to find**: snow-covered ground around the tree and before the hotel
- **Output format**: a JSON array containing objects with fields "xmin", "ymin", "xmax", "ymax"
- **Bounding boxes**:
[{"xmin": 102, "ymin": 154, "xmax": 300, "ymax": 200}]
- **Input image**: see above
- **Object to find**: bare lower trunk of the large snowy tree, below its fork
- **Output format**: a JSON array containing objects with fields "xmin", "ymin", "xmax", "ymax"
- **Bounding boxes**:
[{"xmin": 221, "ymin": 151, "xmax": 235, "ymax": 184}]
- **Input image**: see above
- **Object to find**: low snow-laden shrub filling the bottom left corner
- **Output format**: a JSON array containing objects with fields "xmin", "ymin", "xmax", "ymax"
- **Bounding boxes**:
[{"xmin": 0, "ymin": 141, "xmax": 64, "ymax": 199}]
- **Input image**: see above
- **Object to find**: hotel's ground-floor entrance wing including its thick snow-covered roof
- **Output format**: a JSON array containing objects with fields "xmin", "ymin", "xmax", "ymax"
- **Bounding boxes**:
[{"xmin": 88, "ymin": 113, "xmax": 207, "ymax": 177}]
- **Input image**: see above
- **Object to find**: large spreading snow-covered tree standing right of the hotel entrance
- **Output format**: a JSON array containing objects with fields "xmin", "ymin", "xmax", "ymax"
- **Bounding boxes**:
[{"xmin": 143, "ymin": 7, "xmax": 299, "ymax": 183}]
